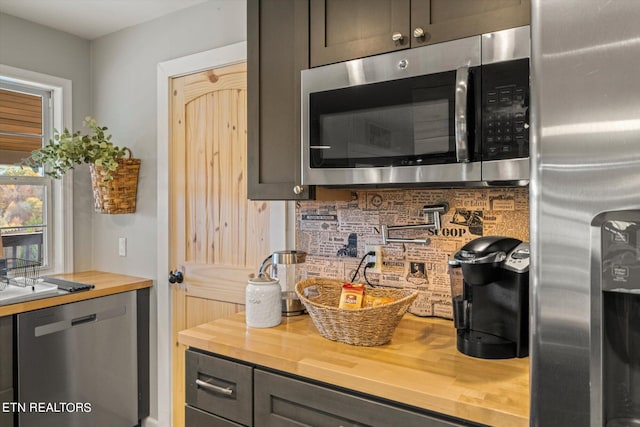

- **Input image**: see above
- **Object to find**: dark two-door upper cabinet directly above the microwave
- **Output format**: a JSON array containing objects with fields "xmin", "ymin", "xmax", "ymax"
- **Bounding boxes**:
[{"xmin": 309, "ymin": 0, "xmax": 531, "ymax": 67}]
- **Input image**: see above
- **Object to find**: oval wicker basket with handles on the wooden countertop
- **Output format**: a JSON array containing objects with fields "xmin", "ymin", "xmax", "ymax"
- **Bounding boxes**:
[{"xmin": 296, "ymin": 278, "xmax": 418, "ymax": 346}]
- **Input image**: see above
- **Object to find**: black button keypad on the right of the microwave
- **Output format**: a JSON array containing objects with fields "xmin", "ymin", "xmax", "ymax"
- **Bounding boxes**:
[{"xmin": 484, "ymin": 85, "xmax": 529, "ymax": 160}]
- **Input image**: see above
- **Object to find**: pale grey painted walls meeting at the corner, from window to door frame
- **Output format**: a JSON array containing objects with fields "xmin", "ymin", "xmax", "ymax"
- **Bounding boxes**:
[{"xmin": 0, "ymin": 0, "xmax": 246, "ymax": 424}]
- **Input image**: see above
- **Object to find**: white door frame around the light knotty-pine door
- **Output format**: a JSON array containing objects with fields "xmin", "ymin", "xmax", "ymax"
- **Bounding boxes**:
[{"xmin": 155, "ymin": 42, "xmax": 294, "ymax": 426}]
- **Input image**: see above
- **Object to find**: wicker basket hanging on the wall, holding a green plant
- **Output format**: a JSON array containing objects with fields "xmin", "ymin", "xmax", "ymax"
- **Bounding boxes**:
[{"xmin": 89, "ymin": 149, "xmax": 140, "ymax": 214}]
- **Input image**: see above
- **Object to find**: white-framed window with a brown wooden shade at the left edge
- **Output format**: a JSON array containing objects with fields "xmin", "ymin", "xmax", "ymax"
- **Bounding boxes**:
[{"xmin": 0, "ymin": 65, "xmax": 72, "ymax": 271}]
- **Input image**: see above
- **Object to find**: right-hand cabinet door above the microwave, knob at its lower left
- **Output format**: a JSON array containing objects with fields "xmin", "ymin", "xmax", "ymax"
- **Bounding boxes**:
[{"xmin": 411, "ymin": 0, "xmax": 531, "ymax": 47}]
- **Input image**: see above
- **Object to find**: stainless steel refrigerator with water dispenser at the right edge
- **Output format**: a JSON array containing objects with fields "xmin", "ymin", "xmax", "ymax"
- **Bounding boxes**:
[{"xmin": 530, "ymin": 0, "xmax": 640, "ymax": 427}]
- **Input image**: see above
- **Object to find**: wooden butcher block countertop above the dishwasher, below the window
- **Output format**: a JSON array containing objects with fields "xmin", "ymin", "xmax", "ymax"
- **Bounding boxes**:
[{"xmin": 0, "ymin": 271, "xmax": 153, "ymax": 317}]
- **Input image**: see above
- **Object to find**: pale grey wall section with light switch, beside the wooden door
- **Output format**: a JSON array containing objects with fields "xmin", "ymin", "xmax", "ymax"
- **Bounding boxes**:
[{"xmin": 91, "ymin": 0, "xmax": 246, "ymax": 422}]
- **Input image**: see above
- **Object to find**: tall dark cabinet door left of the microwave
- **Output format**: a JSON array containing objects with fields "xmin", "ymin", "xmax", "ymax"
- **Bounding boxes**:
[{"xmin": 247, "ymin": 0, "xmax": 310, "ymax": 200}]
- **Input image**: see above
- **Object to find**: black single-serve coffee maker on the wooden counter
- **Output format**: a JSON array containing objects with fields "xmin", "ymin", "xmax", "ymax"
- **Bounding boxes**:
[{"xmin": 449, "ymin": 236, "xmax": 529, "ymax": 359}]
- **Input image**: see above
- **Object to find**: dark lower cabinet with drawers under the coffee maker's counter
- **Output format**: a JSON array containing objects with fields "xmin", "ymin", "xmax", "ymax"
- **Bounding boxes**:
[{"xmin": 185, "ymin": 349, "xmax": 478, "ymax": 427}]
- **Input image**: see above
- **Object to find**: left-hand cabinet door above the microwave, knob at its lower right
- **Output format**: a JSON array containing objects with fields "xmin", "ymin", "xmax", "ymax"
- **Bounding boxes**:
[{"xmin": 309, "ymin": 0, "xmax": 410, "ymax": 67}]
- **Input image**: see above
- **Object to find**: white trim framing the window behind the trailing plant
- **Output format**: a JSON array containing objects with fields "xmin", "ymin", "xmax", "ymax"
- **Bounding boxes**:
[{"xmin": 0, "ymin": 64, "xmax": 73, "ymax": 272}]
